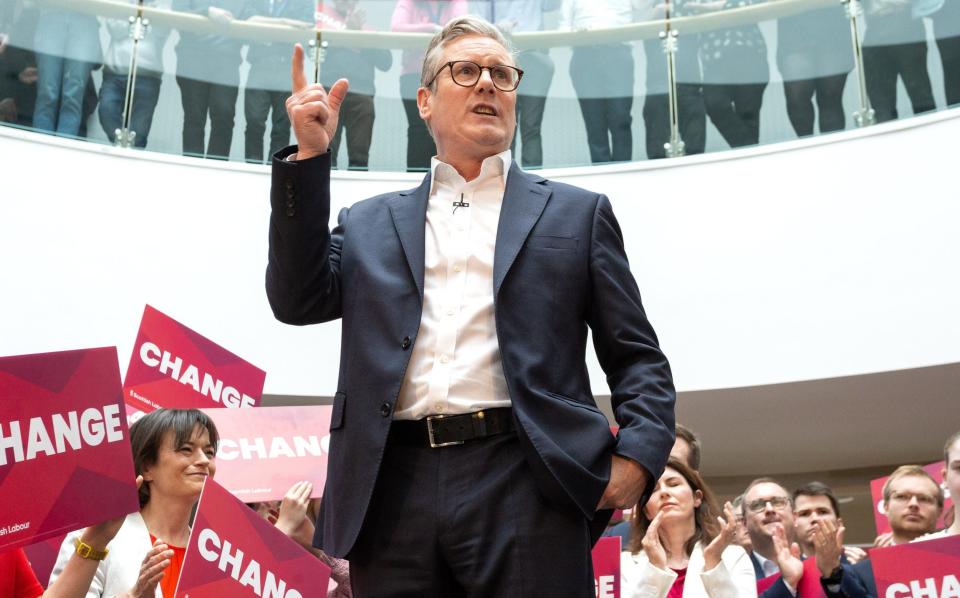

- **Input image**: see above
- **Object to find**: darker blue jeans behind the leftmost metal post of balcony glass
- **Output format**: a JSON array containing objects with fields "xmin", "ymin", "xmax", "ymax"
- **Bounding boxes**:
[{"xmin": 99, "ymin": 71, "xmax": 160, "ymax": 148}]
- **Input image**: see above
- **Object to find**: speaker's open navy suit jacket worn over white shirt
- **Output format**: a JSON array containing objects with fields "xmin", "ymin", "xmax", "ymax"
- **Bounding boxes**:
[{"xmin": 266, "ymin": 148, "xmax": 675, "ymax": 557}]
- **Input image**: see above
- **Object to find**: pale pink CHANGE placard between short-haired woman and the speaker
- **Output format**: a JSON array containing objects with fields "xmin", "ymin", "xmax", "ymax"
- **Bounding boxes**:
[{"xmin": 204, "ymin": 405, "xmax": 333, "ymax": 502}]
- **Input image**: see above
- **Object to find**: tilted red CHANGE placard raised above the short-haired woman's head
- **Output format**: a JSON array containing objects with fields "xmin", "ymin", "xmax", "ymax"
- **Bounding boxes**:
[{"xmin": 123, "ymin": 305, "xmax": 267, "ymax": 420}]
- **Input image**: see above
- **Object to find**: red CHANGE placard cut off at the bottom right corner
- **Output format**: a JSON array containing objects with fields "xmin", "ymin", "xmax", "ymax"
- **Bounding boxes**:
[{"xmin": 870, "ymin": 536, "xmax": 960, "ymax": 598}]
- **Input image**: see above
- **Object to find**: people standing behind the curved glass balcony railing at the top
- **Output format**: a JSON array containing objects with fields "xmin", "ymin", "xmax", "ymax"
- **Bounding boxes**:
[{"xmin": 0, "ymin": 0, "xmax": 960, "ymax": 170}]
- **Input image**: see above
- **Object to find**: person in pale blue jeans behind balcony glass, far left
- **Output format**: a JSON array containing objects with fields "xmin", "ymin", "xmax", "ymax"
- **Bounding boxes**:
[{"xmin": 33, "ymin": 11, "xmax": 100, "ymax": 136}]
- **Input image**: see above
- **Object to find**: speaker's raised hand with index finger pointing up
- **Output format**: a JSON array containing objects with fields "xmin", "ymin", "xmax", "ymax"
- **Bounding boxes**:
[{"xmin": 287, "ymin": 44, "xmax": 350, "ymax": 160}]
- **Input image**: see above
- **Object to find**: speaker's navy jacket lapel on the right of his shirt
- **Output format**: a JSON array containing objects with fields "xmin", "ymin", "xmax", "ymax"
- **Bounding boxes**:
[{"xmin": 493, "ymin": 162, "xmax": 550, "ymax": 297}]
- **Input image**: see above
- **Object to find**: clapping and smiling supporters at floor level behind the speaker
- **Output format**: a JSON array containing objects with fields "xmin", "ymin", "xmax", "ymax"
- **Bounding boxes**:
[{"xmin": 0, "ymin": 409, "xmax": 960, "ymax": 598}]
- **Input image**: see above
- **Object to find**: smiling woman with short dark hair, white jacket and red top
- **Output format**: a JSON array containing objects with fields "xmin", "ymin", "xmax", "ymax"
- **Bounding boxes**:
[{"xmin": 48, "ymin": 409, "xmax": 219, "ymax": 598}]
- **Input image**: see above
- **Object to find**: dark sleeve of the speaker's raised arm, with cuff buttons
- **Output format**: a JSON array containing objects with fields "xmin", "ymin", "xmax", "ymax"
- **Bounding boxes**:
[{"xmin": 266, "ymin": 146, "xmax": 347, "ymax": 325}]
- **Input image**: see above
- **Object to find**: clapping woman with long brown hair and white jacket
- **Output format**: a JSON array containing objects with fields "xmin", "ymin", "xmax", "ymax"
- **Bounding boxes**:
[{"xmin": 620, "ymin": 458, "xmax": 757, "ymax": 598}]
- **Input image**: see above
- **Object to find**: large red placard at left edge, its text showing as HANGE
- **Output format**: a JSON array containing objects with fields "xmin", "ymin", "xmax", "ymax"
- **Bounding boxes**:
[{"xmin": 0, "ymin": 347, "xmax": 139, "ymax": 550}]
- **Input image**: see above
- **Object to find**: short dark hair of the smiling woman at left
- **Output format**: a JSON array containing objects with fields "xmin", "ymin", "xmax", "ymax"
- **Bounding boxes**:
[{"xmin": 130, "ymin": 409, "xmax": 220, "ymax": 509}]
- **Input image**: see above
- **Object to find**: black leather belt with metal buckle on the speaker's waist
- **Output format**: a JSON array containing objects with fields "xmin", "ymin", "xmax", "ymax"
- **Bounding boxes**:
[{"xmin": 388, "ymin": 407, "xmax": 513, "ymax": 448}]
